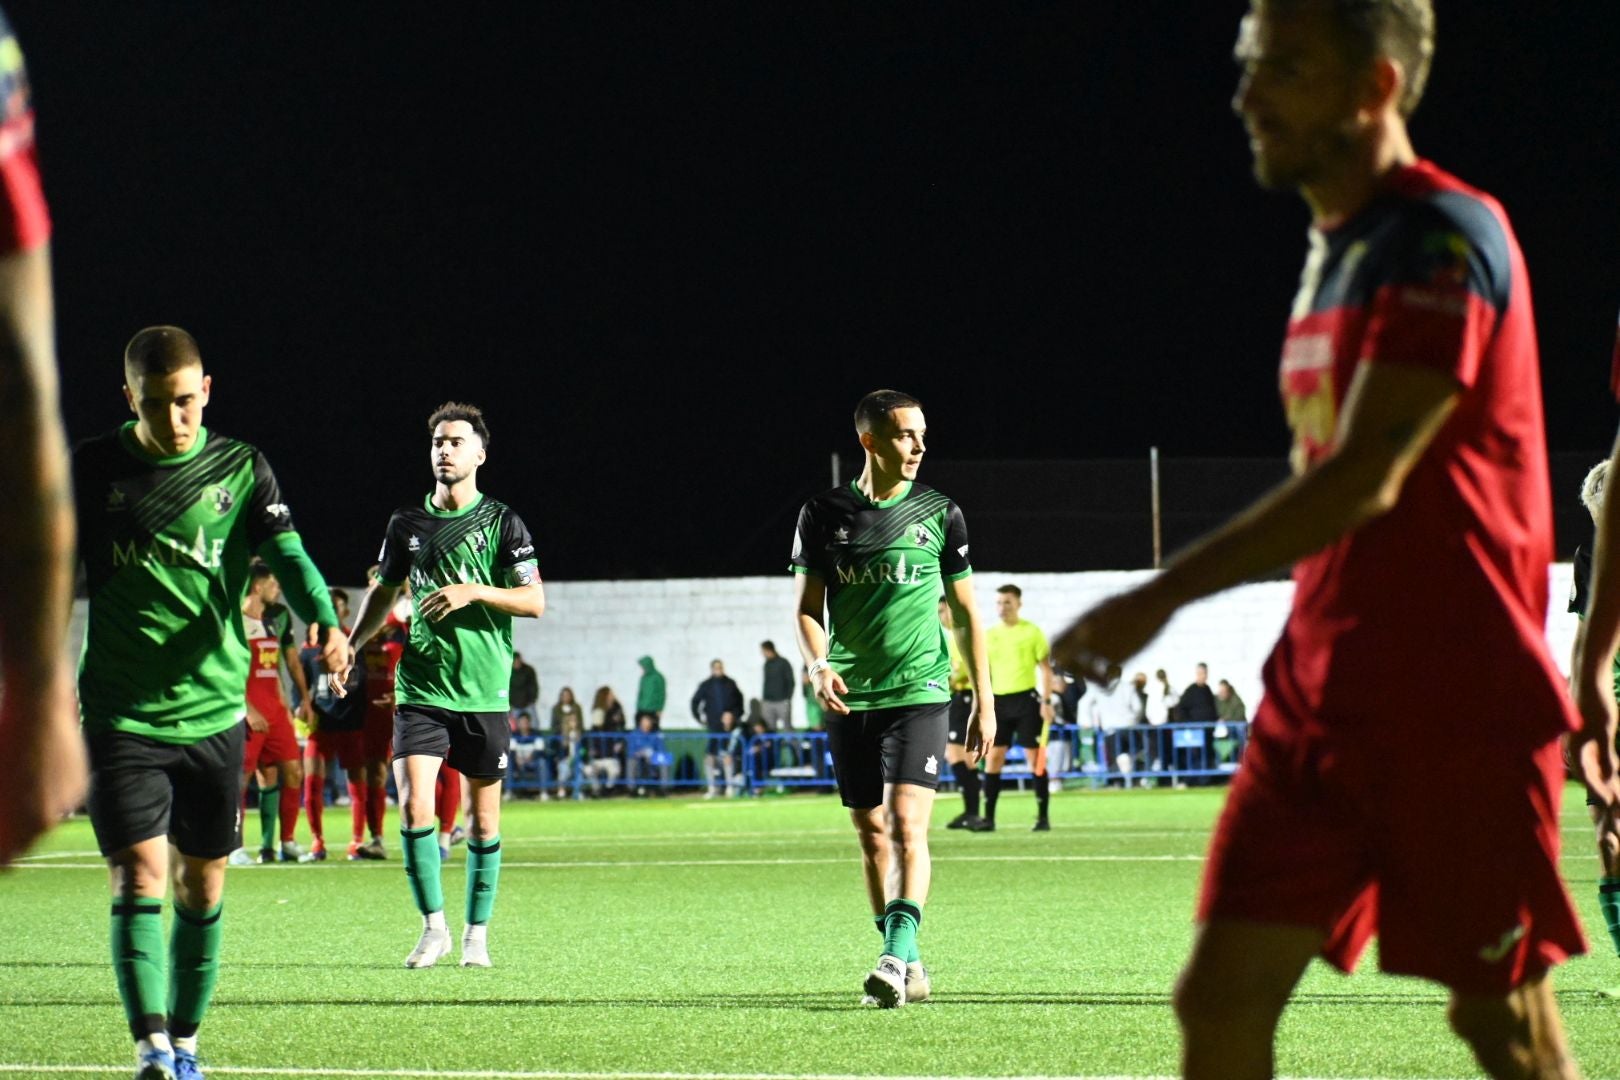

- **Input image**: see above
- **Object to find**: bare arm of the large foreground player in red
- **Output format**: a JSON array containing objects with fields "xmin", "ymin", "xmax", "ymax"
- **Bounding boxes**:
[{"xmin": 1051, "ymin": 363, "xmax": 1460, "ymax": 678}]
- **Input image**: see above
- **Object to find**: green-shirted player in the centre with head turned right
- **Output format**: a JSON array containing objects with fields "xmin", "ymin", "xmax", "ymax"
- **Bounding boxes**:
[{"xmin": 791, "ymin": 390, "xmax": 996, "ymax": 1009}]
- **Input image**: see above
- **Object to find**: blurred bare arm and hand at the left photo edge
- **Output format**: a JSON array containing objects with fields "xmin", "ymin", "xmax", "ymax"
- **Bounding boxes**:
[{"xmin": 0, "ymin": 246, "xmax": 86, "ymax": 866}]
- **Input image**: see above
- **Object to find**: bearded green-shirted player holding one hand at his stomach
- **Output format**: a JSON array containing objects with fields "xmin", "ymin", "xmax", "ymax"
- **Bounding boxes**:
[{"xmin": 332, "ymin": 402, "xmax": 546, "ymax": 968}]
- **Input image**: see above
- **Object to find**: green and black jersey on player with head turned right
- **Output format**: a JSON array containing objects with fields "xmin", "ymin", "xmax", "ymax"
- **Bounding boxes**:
[{"xmin": 789, "ymin": 483, "xmax": 974, "ymax": 709}]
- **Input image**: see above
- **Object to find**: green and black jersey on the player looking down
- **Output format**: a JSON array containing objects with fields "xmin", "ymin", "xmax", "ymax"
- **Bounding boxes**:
[{"xmin": 73, "ymin": 421, "xmax": 293, "ymax": 743}]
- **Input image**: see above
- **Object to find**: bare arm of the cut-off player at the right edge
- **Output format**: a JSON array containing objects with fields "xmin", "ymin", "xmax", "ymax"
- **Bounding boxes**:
[{"xmin": 1568, "ymin": 420, "xmax": 1620, "ymax": 809}]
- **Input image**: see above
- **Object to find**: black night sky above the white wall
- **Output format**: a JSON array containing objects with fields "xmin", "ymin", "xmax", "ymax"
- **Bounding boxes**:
[{"xmin": 15, "ymin": 0, "xmax": 1620, "ymax": 581}]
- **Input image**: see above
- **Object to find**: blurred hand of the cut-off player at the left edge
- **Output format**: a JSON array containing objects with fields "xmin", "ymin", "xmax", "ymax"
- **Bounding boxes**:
[{"xmin": 0, "ymin": 662, "xmax": 87, "ymax": 866}]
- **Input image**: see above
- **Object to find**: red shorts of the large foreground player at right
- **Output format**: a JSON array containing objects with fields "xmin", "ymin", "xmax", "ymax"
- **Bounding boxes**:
[{"xmin": 1199, "ymin": 699, "xmax": 1586, "ymax": 994}]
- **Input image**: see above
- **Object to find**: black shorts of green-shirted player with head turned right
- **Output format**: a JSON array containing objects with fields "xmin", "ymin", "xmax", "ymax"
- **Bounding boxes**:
[{"xmin": 823, "ymin": 701, "xmax": 951, "ymax": 810}]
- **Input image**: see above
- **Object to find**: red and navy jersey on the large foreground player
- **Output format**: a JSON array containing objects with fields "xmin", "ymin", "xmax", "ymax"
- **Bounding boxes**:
[{"xmin": 1265, "ymin": 162, "xmax": 1573, "ymax": 742}]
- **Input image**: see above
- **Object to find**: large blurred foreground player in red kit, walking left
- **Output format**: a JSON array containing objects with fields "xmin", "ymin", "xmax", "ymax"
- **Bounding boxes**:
[{"xmin": 1053, "ymin": 0, "xmax": 1587, "ymax": 1080}]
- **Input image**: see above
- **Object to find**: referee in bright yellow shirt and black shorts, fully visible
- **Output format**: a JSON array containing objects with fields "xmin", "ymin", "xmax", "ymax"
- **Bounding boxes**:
[{"xmin": 967, "ymin": 585, "xmax": 1051, "ymax": 832}]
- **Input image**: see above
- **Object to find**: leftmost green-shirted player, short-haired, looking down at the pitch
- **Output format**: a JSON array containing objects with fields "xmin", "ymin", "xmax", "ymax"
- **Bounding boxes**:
[{"xmin": 73, "ymin": 327, "xmax": 348, "ymax": 1080}]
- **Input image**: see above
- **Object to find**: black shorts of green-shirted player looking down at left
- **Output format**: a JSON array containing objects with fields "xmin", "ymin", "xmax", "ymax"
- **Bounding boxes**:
[{"xmin": 84, "ymin": 724, "xmax": 248, "ymax": 858}]
